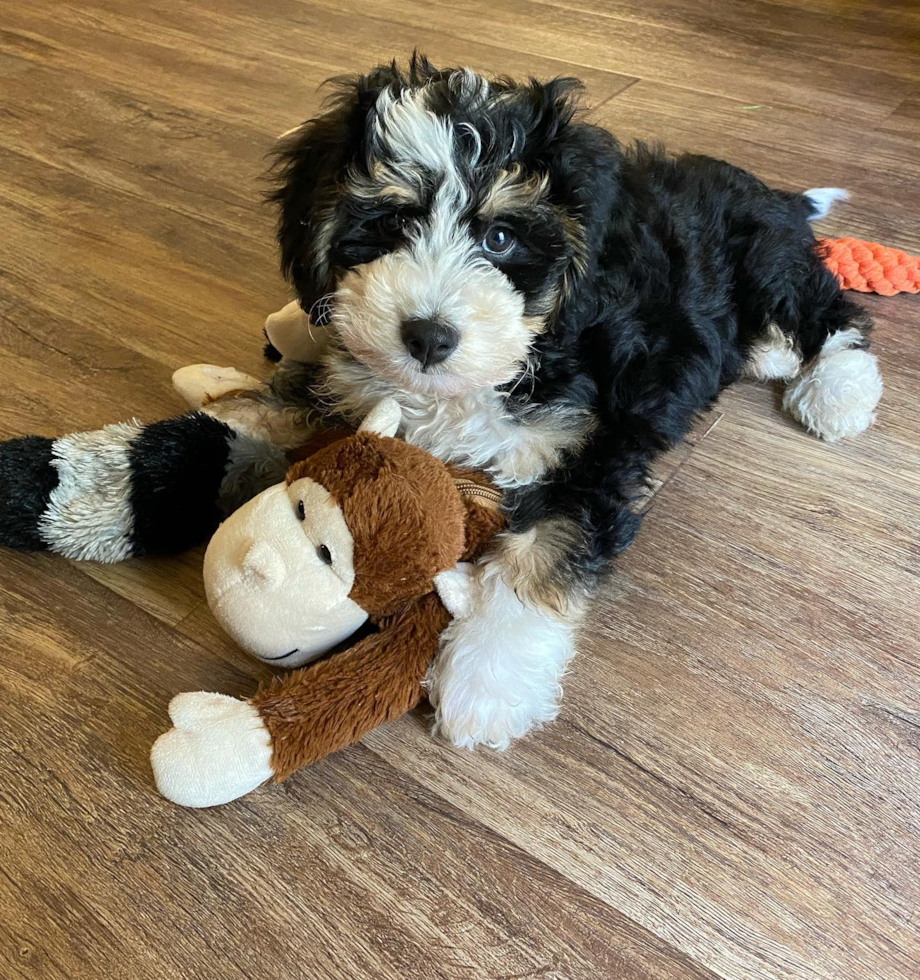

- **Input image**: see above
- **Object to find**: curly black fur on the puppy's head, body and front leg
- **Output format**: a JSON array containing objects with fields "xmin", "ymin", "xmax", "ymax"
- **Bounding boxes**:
[{"xmin": 274, "ymin": 56, "xmax": 869, "ymax": 588}]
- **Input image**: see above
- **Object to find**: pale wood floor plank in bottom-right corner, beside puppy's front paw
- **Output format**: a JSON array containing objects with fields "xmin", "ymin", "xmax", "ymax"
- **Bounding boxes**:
[{"xmin": 369, "ymin": 390, "xmax": 920, "ymax": 980}]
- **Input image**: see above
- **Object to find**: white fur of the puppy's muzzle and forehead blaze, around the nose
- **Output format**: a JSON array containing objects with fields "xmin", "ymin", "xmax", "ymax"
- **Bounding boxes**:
[{"xmin": 332, "ymin": 73, "xmax": 543, "ymax": 396}]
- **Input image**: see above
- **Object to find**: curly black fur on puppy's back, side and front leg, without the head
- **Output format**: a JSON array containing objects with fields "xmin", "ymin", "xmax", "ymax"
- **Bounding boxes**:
[{"xmin": 511, "ymin": 149, "xmax": 869, "ymax": 580}]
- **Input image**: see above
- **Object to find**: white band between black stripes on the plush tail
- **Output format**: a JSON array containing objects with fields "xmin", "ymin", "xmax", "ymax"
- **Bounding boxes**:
[{"xmin": 38, "ymin": 422, "xmax": 142, "ymax": 562}]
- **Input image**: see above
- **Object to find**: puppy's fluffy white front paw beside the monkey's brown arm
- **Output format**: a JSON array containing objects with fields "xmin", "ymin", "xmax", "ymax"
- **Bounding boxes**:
[{"xmin": 426, "ymin": 563, "xmax": 573, "ymax": 749}]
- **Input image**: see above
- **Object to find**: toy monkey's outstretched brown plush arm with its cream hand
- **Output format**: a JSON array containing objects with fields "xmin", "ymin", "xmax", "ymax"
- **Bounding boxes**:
[{"xmin": 150, "ymin": 594, "xmax": 450, "ymax": 807}]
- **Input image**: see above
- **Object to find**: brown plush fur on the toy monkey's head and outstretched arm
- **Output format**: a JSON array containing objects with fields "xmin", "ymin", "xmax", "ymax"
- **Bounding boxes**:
[{"xmin": 251, "ymin": 434, "xmax": 502, "ymax": 780}]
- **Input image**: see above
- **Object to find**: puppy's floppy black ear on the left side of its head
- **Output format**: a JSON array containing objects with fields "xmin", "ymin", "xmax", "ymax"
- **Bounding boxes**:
[{"xmin": 269, "ymin": 62, "xmax": 403, "ymax": 322}]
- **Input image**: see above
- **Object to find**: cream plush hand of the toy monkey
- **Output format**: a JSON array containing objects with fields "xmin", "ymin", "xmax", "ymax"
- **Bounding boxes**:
[{"xmin": 150, "ymin": 691, "xmax": 273, "ymax": 807}]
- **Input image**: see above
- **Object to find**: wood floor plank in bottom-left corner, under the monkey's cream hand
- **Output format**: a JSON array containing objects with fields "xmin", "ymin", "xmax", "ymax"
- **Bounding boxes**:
[{"xmin": 0, "ymin": 557, "xmax": 711, "ymax": 980}]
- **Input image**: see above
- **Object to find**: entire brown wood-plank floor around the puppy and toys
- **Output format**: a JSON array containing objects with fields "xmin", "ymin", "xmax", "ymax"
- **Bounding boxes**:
[{"xmin": 0, "ymin": 0, "xmax": 920, "ymax": 980}]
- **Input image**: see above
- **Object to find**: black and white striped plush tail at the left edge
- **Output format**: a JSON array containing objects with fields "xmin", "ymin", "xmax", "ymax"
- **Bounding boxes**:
[{"xmin": 0, "ymin": 412, "xmax": 287, "ymax": 562}]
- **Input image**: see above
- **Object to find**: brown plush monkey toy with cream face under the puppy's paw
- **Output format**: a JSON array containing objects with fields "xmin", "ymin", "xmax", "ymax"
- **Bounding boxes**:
[{"xmin": 151, "ymin": 399, "xmax": 503, "ymax": 807}]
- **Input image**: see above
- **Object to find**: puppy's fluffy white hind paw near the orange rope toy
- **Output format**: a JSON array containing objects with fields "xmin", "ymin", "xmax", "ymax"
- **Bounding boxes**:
[{"xmin": 783, "ymin": 329, "xmax": 882, "ymax": 442}]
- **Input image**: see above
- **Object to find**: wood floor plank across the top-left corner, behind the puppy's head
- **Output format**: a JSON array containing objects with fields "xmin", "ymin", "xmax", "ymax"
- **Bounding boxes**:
[{"xmin": 0, "ymin": 0, "xmax": 632, "ymax": 136}]
